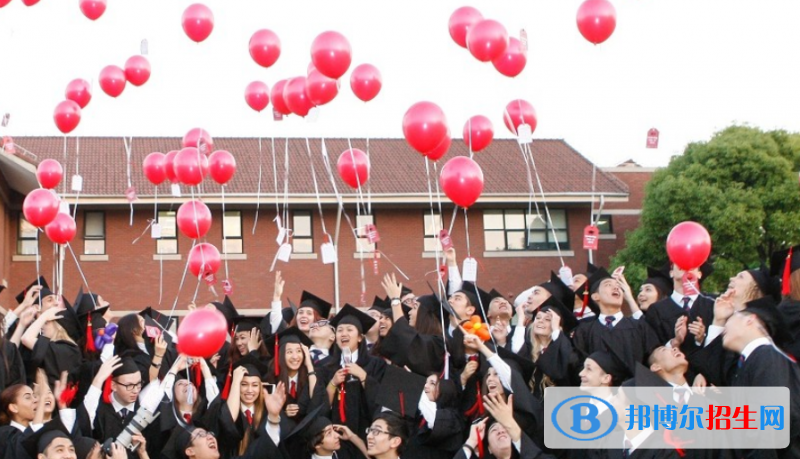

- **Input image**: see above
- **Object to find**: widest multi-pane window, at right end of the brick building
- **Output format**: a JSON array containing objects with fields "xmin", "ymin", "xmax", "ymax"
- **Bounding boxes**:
[{"xmin": 483, "ymin": 209, "xmax": 569, "ymax": 251}]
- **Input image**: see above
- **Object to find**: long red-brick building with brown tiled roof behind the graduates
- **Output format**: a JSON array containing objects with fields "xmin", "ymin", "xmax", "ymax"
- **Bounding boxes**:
[{"xmin": 0, "ymin": 137, "xmax": 652, "ymax": 313}]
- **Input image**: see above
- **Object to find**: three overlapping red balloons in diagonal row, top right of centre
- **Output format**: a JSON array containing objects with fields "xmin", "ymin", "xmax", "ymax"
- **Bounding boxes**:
[{"xmin": 449, "ymin": 6, "xmax": 528, "ymax": 78}]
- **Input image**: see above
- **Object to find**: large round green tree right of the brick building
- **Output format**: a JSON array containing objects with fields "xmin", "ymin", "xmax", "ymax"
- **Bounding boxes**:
[{"xmin": 613, "ymin": 126, "xmax": 800, "ymax": 291}]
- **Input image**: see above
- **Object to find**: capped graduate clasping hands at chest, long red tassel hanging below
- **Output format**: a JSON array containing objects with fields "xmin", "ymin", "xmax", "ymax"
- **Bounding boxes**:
[{"xmin": 317, "ymin": 306, "xmax": 386, "ymax": 446}]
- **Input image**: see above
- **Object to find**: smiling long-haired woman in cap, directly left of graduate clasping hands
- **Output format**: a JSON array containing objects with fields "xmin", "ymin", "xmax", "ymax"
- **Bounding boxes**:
[{"xmin": 267, "ymin": 327, "xmax": 324, "ymax": 422}]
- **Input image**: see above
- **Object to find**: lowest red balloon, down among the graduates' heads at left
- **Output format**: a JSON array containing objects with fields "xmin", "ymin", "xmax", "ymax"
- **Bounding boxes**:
[{"xmin": 178, "ymin": 309, "xmax": 228, "ymax": 359}]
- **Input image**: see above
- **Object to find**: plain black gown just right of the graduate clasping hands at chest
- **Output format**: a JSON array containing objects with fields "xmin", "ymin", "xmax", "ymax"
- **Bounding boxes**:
[{"xmin": 380, "ymin": 317, "xmax": 444, "ymax": 375}]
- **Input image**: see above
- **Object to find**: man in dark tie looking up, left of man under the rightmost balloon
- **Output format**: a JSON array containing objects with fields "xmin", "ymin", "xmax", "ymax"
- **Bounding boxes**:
[{"xmin": 572, "ymin": 268, "xmax": 660, "ymax": 374}]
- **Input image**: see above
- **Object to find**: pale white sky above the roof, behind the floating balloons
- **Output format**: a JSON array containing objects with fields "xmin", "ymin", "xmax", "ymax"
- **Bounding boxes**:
[{"xmin": 0, "ymin": 0, "xmax": 800, "ymax": 166}]
